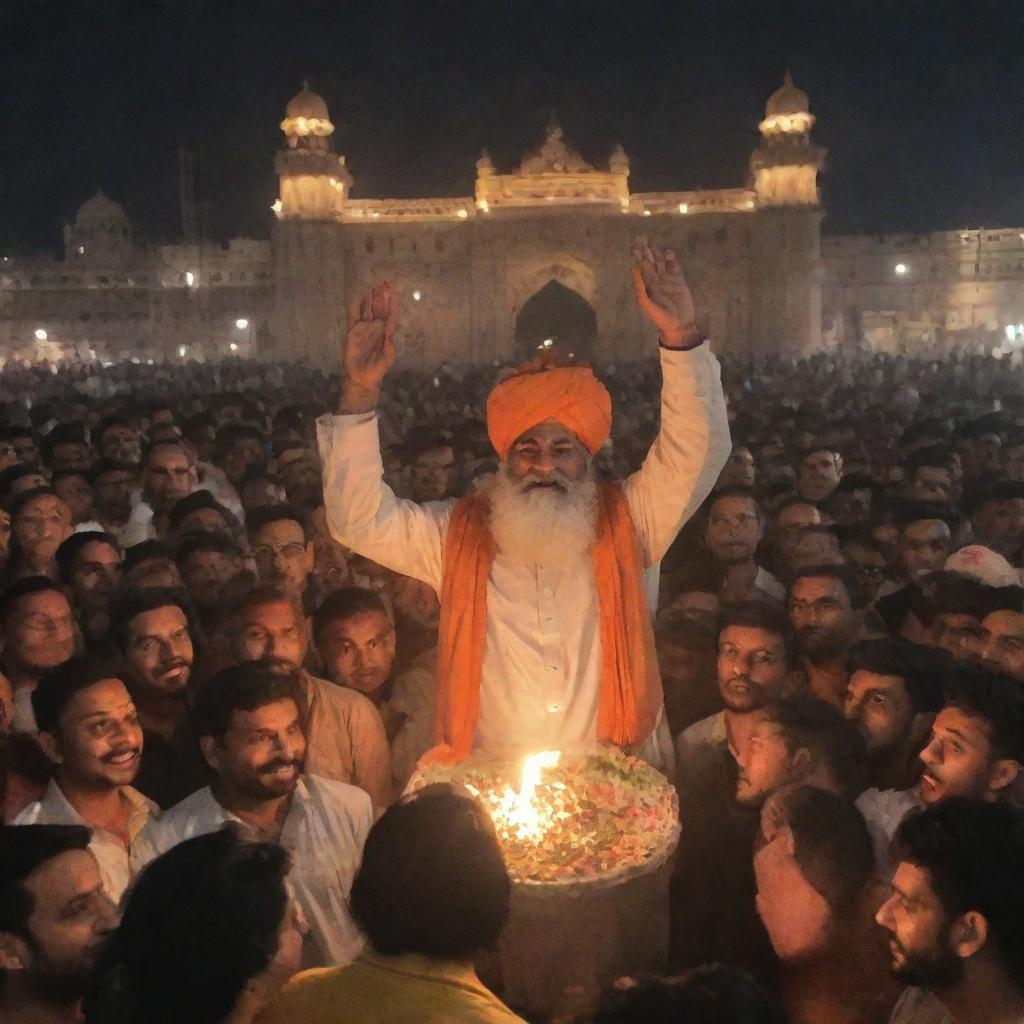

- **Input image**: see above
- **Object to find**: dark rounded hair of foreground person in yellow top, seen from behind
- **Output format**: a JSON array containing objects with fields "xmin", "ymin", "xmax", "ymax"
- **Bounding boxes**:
[{"xmin": 350, "ymin": 786, "xmax": 511, "ymax": 959}]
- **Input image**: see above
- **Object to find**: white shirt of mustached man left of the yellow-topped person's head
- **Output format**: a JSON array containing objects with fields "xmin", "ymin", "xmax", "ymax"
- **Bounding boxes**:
[{"xmin": 141, "ymin": 775, "xmax": 374, "ymax": 966}]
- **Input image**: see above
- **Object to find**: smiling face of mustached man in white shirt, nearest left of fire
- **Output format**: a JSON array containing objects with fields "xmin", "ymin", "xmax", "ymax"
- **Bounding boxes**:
[{"xmin": 202, "ymin": 699, "xmax": 306, "ymax": 800}]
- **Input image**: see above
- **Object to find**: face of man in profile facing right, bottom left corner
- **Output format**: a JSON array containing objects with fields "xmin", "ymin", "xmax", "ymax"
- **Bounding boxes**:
[{"xmin": 0, "ymin": 850, "xmax": 118, "ymax": 1006}]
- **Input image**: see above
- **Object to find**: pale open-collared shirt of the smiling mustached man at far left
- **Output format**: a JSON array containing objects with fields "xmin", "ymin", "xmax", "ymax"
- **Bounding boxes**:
[{"xmin": 14, "ymin": 779, "xmax": 160, "ymax": 904}]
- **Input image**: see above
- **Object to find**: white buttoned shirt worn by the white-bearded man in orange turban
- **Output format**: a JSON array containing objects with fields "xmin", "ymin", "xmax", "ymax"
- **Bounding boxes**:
[{"xmin": 317, "ymin": 344, "xmax": 731, "ymax": 765}]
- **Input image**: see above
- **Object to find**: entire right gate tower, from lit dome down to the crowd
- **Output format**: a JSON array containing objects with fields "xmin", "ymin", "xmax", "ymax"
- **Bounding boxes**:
[{"xmin": 748, "ymin": 72, "xmax": 824, "ymax": 352}]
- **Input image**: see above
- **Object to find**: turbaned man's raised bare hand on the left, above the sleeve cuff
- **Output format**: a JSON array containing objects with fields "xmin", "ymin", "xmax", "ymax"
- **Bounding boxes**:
[{"xmin": 338, "ymin": 281, "xmax": 398, "ymax": 413}]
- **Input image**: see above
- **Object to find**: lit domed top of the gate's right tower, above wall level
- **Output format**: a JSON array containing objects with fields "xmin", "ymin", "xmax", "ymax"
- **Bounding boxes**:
[{"xmin": 751, "ymin": 72, "xmax": 825, "ymax": 207}]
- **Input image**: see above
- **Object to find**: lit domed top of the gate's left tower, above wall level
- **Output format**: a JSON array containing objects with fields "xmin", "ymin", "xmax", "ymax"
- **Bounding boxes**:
[{"xmin": 273, "ymin": 83, "xmax": 352, "ymax": 220}]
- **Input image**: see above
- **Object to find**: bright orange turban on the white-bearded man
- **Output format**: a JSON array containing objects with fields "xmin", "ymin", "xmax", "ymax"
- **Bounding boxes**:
[{"xmin": 487, "ymin": 361, "xmax": 611, "ymax": 460}]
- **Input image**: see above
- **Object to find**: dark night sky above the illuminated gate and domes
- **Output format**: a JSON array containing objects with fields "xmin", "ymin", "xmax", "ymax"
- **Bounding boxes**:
[{"xmin": 0, "ymin": 0, "xmax": 1024, "ymax": 253}]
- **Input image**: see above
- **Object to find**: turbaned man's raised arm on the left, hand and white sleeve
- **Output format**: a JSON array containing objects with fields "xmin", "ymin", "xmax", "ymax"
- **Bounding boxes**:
[{"xmin": 316, "ymin": 283, "xmax": 451, "ymax": 590}]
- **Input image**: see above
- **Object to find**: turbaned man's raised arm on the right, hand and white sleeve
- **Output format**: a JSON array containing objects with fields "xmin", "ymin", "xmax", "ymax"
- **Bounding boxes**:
[{"xmin": 624, "ymin": 244, "xmax": 732, "ymax": 565}]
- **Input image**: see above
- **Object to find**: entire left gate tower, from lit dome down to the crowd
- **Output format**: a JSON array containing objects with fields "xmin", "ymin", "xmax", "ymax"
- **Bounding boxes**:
[{"xmin": 269, "ymin": 84, "xmax": 352, "ymax": 366}]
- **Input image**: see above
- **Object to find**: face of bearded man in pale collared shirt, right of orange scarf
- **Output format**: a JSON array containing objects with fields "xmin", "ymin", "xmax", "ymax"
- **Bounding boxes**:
[{"xmin": 718, "ymin": 626, "xmax": 791, "ymax": 714}]
